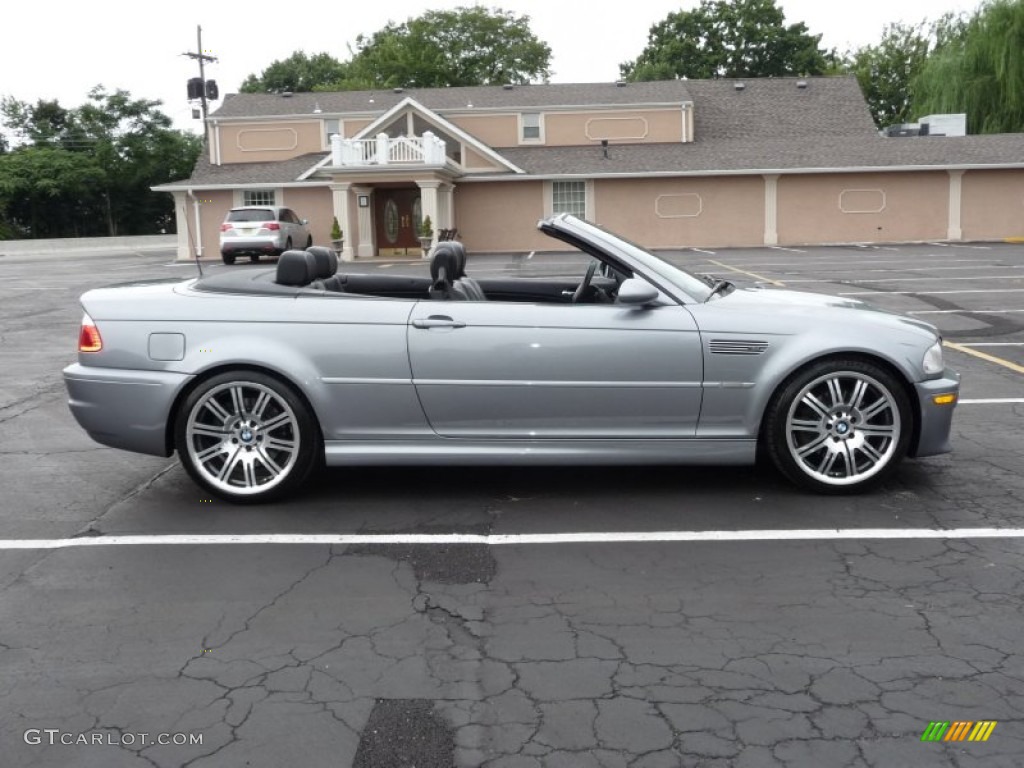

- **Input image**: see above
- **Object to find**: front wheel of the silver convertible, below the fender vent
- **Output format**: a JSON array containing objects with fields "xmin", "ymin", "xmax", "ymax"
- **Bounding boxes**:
[{"xmin": 764, "ymin": 359, "xmax": 913, "ymax": 494}]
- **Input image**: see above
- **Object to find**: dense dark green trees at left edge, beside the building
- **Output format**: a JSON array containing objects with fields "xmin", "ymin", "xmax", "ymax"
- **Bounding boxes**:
[{"xmin": 0, "ymin": 86, "xmax": 202, "ymax": 238}]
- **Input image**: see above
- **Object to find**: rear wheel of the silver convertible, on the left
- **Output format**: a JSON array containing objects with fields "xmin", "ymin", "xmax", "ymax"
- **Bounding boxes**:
[{"xmin": 174, "ymin": 371, "xmax": 322, "ymax": 504}]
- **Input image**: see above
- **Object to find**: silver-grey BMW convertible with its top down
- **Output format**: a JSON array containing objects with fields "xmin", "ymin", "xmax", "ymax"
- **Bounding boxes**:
[{"xmin": 65, "ymin": 214, "xmax": 959, "ymax": 502}]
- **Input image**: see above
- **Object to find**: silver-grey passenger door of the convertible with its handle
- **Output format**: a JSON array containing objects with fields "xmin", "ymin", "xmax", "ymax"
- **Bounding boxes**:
[{"xmin": 408, "ymin": 301, "xmax": 702, "ymax": 438}]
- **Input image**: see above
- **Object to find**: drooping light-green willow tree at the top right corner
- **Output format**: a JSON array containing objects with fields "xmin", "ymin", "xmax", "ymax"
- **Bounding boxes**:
[{"xmin": 912, "ymin": 0, "xmax": 1024, "ymax": 133}]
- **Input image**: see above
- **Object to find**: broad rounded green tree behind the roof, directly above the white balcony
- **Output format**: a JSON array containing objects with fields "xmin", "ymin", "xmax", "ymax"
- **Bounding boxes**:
[{"xmin": 337, "ymin": 5, "xmax": 551, "ymax": 88}]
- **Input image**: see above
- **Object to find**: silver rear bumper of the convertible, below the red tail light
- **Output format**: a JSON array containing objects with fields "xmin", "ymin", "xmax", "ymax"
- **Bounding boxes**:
[{"xmin": 63, "ymin": 362, "xmax": 191, "ymax": 456}]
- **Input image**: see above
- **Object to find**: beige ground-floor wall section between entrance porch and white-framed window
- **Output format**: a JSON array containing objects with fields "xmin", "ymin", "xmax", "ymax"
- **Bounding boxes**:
[{"xmin": 455, "ymin": 181, "xmax": 568, "ymax": 254}]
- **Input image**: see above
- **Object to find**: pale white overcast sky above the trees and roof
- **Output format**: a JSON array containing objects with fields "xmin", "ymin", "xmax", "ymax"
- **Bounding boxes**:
[{"xmin": 0, "ymin": 0, "xmax": 979, "ymax": 137}]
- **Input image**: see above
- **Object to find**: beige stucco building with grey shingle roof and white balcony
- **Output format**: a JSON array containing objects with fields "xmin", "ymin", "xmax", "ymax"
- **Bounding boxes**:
[{"xmin": 157, "ymin": 77, "xmax": 1024, "ymax": 258}]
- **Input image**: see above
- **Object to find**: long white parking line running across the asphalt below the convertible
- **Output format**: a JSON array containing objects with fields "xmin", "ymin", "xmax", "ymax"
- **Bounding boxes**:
[{"xmin": 0, "ymin": 528, "xmax": 1024, "ymax": 550}]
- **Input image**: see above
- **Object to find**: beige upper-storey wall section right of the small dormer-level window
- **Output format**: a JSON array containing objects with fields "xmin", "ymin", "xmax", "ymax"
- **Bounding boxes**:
[{"xmin": 544, "ymin": 109, "xmax": 683, "ymax": 146}]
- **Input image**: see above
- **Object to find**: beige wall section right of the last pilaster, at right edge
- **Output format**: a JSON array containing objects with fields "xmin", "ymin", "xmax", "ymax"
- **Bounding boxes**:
[{"xmin": 961, "ymin": 170, "xmax": 1024, "ymax": 240}]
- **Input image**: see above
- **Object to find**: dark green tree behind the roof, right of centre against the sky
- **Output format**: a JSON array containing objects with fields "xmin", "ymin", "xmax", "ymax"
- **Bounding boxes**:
[{"xmin": 620, "ymin": 0, "xmax": 828, "ymax": 80}]
